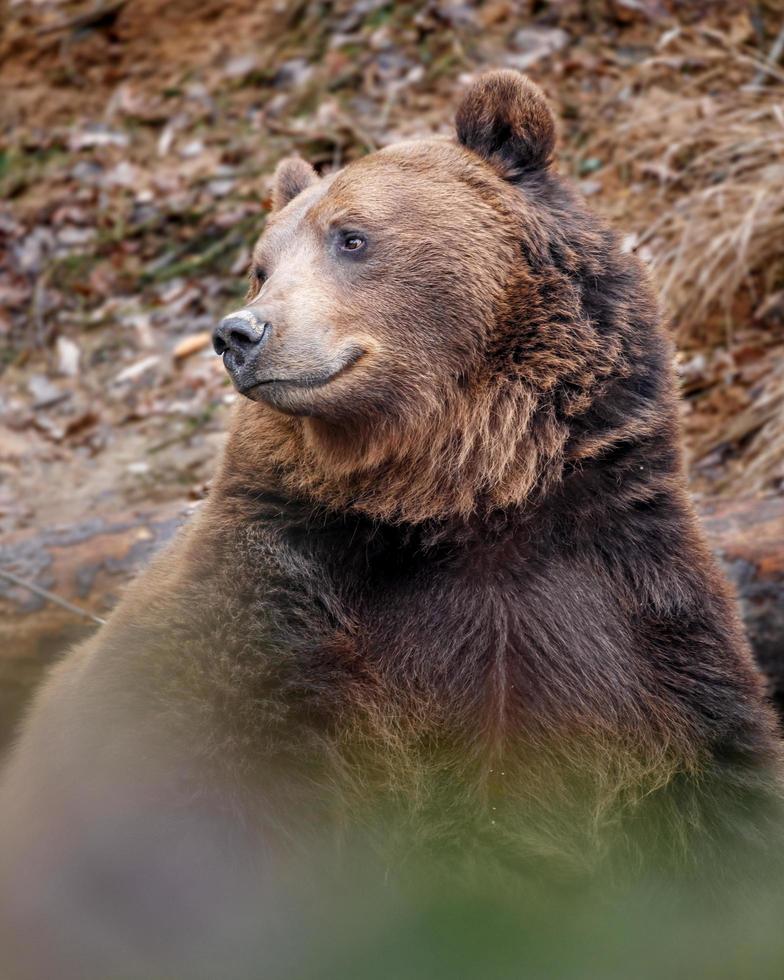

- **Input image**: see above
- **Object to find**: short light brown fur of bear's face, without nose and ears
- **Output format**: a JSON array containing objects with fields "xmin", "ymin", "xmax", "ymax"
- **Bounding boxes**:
[{"xmin": 242, "ymin": 142, "xmax": 516, "ymax": 412}]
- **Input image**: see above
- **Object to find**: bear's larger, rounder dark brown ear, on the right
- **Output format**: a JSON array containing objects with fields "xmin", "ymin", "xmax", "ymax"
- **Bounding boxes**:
[{"xmin": 455, "ymin": 71, "xmax": 555, "ymax": 180}]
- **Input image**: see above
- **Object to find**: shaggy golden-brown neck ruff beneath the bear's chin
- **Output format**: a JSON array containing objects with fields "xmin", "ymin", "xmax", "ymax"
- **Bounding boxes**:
[{"xmin": 213, "ymin": 380, "xmax": 568, "ymax": 525}]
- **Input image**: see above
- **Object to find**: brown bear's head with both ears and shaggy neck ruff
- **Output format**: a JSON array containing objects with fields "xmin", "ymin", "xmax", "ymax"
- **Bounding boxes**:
[{"xmin": 214, "ymin": 71, "xmax": 672, "ymax": 521}]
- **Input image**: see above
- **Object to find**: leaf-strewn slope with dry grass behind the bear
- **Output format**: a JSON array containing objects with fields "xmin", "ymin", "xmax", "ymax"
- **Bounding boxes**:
[{"xmin": 0, "ymin": 0, "xmax": 784, "ymax": 534}]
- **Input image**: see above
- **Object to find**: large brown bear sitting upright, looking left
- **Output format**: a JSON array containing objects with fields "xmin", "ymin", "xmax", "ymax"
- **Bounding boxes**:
[{"xmin": 0, "ymin": 72, "xmax": 780, "ymax": 976}]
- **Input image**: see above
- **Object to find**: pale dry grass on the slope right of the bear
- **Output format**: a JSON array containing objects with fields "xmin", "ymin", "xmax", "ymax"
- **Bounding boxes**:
[{"xmin": 588, "ymin": 28, "xmax": 784, "ymax": 493}]
